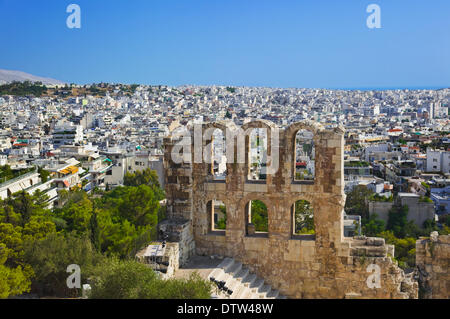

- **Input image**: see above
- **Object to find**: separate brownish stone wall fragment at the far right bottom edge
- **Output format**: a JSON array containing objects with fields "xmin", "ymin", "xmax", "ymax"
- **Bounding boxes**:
[{"xmin": 416, "ymin": 232, "xmax": 450, "ymax": 299}]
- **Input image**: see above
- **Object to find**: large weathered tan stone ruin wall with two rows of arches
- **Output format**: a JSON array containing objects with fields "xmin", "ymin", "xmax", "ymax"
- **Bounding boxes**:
[{"xmin": 160, "ymin": 120, "xmax": 418, "ymax": 298}]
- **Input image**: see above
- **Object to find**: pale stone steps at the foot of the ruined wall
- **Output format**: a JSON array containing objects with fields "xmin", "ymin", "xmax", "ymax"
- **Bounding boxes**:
[{"xmin": 208, "ymin": 258, "xmax": 286, "ymax": 299}]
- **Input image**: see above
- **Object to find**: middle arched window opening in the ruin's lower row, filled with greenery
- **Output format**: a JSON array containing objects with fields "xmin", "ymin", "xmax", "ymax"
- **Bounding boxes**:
[{"xmin": 245, "ymin": 200, "xmax": 269, "ymax": 236}]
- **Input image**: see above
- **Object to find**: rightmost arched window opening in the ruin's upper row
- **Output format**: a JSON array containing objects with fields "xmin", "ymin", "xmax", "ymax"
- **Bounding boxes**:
[{"xmin": 293, "ymin": 130, "xmax": 316, "ymax": 181}]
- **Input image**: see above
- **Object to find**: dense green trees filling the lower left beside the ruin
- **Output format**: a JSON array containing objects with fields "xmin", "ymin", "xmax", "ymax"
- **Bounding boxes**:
[{"xmin": 0, "ymin": 169, "xmax": 211, "ymax": 299}]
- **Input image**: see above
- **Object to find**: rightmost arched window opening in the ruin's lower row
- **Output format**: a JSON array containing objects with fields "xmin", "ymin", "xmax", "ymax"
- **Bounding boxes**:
[{"xmin": 292, "ymin": 199, "xmax": 315, "ymax": 237}]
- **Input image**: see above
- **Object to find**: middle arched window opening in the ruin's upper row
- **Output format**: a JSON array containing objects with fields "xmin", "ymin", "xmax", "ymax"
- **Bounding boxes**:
[{"xmin": 248, "ymin": 128, "xmax": 268, "ymax": 181}]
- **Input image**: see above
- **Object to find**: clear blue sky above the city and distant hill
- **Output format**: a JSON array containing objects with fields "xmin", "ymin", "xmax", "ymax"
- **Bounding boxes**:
[{"xmin": 0, "ymin": 0, "xmax": 450, "ymax": 88}]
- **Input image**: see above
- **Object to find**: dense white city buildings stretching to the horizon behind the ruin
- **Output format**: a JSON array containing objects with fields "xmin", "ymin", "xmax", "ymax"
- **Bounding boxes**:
[{"xmin": 0, "ymin": 83, "xmax": 450, "ymax": 212}]
